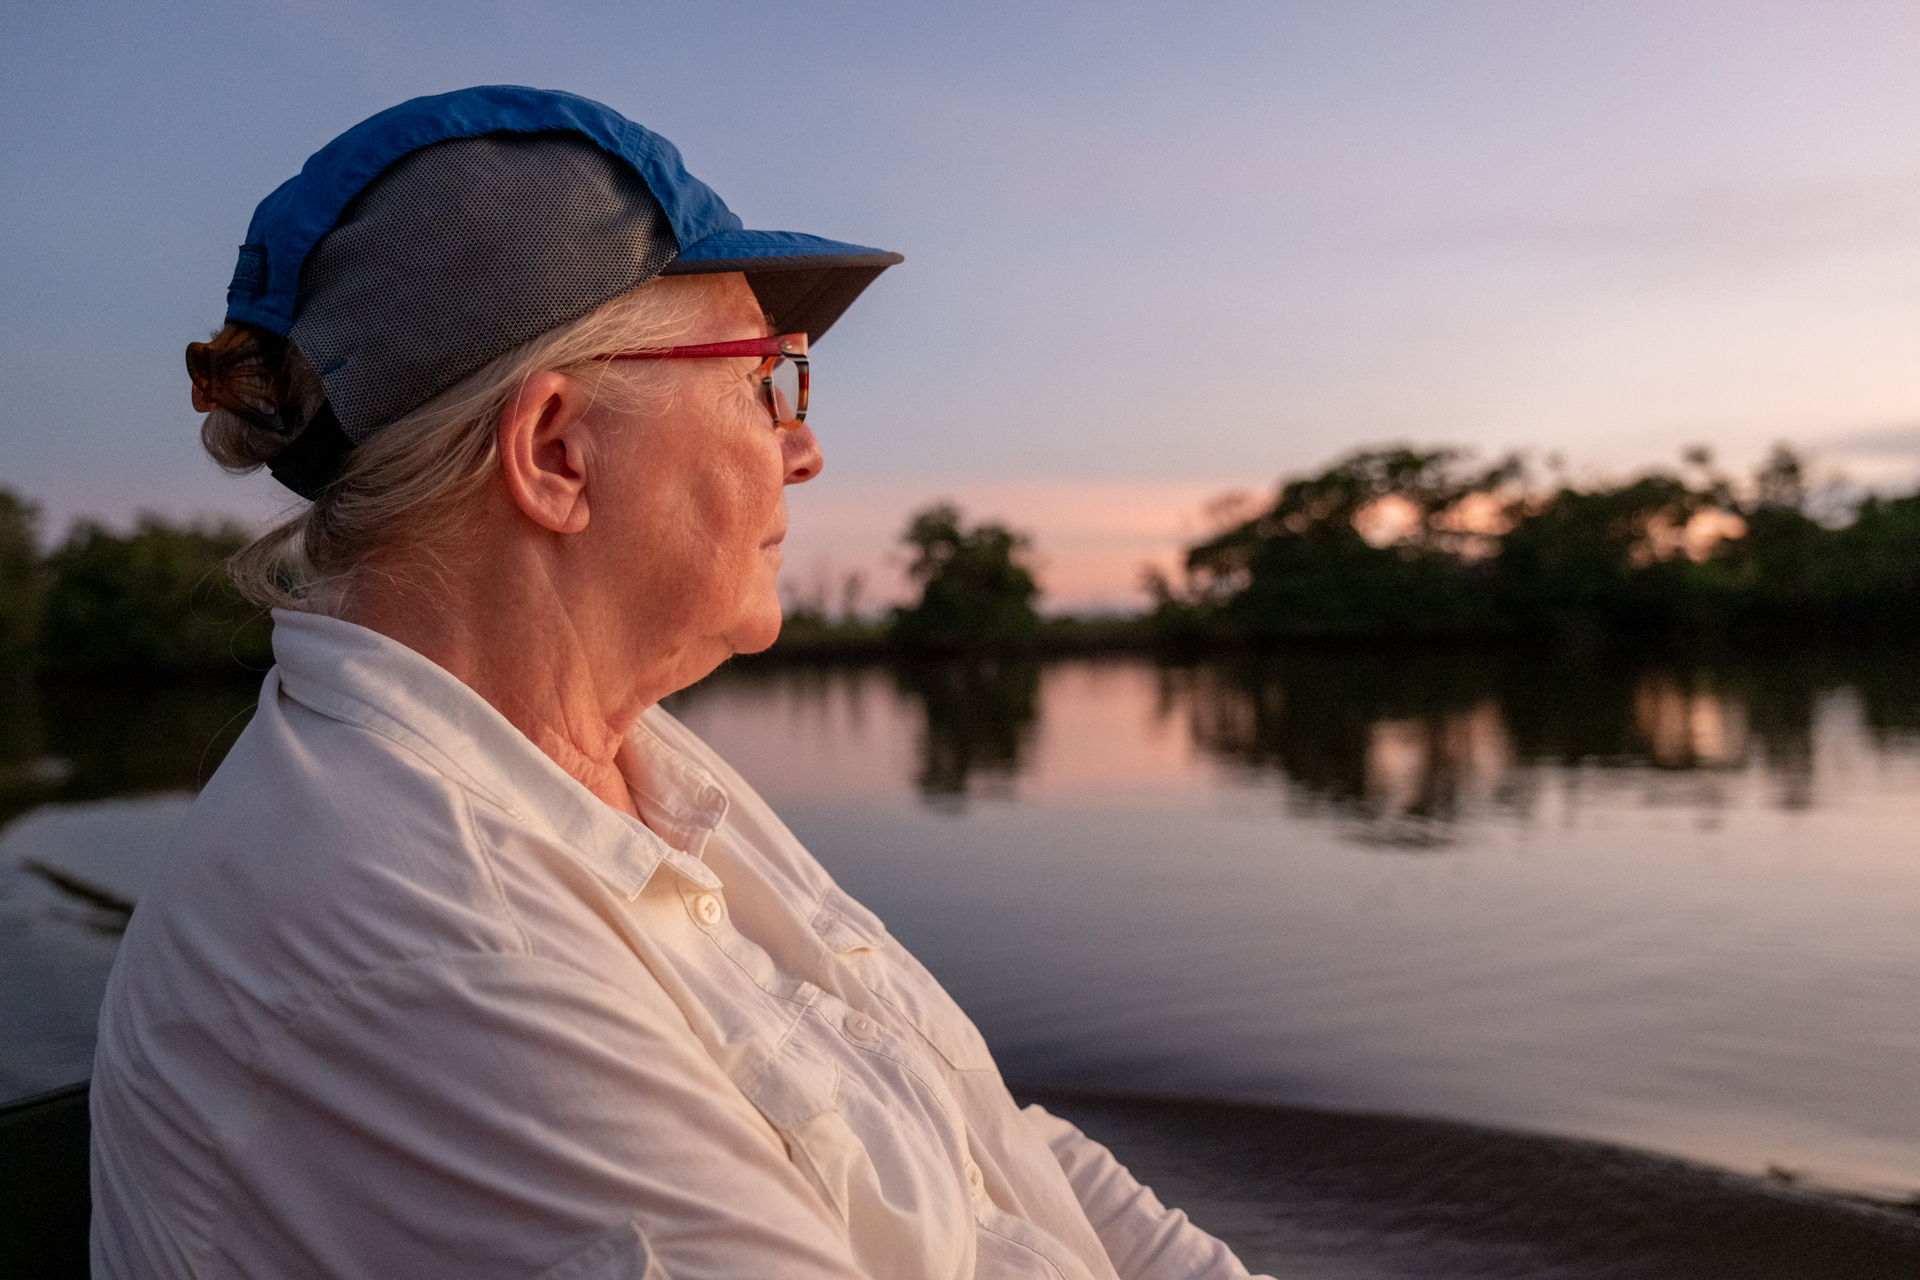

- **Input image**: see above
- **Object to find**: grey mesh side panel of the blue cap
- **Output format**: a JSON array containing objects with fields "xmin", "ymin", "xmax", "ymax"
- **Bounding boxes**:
[{"xmin": 288, "ymin": 132, "xmax": 680, "ymax": 443}]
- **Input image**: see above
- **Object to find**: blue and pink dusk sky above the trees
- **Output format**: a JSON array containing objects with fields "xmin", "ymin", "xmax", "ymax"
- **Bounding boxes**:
[{"xmin": 0, "ymin": 0, "xmax": 1920, "ymax": 606}]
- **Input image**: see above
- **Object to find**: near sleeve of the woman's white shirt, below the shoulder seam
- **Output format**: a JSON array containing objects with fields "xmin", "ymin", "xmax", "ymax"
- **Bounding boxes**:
[{"xmin": 211, "ymin": 954, "xmax": 862, "ymax": 1280}]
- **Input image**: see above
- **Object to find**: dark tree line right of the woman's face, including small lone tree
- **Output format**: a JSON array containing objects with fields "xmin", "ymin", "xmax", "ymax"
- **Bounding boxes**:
[{"xmin": 793, "ymin": 445, "xmax": 1920, "ymax": 652}]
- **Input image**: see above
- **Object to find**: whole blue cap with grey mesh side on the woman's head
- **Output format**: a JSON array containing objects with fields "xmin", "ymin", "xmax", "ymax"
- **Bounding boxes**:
[{"xmin": 214, "ymin": 84, "xmax": 902, "ymax": 497}]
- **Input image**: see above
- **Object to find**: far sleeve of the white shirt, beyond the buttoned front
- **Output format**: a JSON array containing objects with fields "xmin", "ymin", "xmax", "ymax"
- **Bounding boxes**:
[{"xmin": 1023, "ymin": 1103, "xmax": 1271, "ymax": 1280}]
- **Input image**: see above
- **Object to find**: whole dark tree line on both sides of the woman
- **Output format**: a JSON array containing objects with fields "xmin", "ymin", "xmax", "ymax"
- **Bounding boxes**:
[{"xmin": 15, "ymin": 445, "xmax": 1920, "ymax": 676}]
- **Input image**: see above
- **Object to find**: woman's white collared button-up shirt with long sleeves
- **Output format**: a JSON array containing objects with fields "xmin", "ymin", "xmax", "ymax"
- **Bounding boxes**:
[{"xmin": 92, "ymin": 612, "xmax": 1246, "ymax": 1280}]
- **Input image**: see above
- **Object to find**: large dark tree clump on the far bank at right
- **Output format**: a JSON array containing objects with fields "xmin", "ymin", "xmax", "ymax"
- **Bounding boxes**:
[{"xmin": 1148, "ymin": 447, "xmax": 1920, "ymax": 643}]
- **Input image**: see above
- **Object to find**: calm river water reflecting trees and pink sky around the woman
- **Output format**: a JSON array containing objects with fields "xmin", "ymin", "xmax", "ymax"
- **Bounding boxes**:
[{"xmin": 11, "ymin": 649, "xmax": 1920, "ymax": 1276}]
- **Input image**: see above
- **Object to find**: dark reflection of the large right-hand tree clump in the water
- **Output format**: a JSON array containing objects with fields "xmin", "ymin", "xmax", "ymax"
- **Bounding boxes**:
[{"xmin": 1160, "ymin": 647, "xmax": 1920, "ymax": 848}]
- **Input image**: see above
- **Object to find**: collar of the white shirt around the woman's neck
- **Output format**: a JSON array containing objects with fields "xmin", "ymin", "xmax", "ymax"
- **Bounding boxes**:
[{"xmin": 273, "ymin": 608, "xmax": 728, "ymax": 898}]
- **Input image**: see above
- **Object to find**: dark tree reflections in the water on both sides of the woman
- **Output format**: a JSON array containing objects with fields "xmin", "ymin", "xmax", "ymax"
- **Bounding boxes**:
[{"xmin": 0, "ymin": 649, "xmax": 1920, "ymax": 836}]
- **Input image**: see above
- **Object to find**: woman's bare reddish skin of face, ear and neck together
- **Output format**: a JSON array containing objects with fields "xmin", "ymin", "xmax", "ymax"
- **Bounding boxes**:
[{"xmin": 348, "ymin": 274, "xmax": 822, "ymax": 816}]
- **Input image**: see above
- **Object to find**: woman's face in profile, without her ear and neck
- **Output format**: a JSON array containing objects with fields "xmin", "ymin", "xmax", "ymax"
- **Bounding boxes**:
[{"xmin": 586, "ymin": 274, "xmax": 822, "ymax": 683}]
